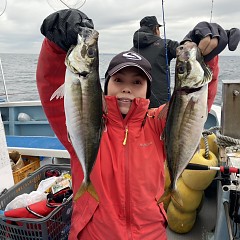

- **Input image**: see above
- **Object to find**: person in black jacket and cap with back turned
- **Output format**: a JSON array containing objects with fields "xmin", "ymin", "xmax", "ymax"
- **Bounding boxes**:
[{"xmin": 131, "ymin": 16, "xmax": 179, "ymax": 108}]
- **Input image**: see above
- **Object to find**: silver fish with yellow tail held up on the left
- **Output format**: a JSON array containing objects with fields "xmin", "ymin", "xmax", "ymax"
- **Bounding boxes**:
[{"xmin": 51, "ymin": 28, "xmax": 103, "ymax": 201}]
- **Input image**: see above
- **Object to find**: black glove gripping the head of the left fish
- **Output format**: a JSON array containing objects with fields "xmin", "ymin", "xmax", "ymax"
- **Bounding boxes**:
[{"xmin": 41, "ymin": 9, "xmax": 94, "ymax": 51}]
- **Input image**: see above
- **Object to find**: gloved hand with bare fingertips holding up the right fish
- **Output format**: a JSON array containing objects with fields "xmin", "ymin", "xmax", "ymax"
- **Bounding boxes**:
[{"xmin": 181, "ymin": 22, "xmax": 240, "ymax": 61}]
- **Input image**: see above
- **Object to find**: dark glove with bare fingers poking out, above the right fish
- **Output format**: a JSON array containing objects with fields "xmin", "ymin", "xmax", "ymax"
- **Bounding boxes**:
[{"xmin": 181, "ymin": 22, "xmax": 240, "ymax": 61}]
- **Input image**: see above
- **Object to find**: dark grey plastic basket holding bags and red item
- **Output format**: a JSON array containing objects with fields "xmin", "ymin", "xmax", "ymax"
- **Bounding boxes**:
[{"xmin": 0, "ymin": 164, "xmax": 72, "ymax": 240}]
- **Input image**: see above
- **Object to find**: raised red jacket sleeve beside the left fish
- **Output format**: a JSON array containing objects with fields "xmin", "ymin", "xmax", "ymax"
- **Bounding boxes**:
[{"xmin": 36, "ymin": 38, "xmax": 82, "ymax": 192}]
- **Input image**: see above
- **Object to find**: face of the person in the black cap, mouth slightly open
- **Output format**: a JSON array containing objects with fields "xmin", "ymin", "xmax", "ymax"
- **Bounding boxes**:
[{"xmin": 108, "ymin": 67, "xmax": 147, "ymax": 114}]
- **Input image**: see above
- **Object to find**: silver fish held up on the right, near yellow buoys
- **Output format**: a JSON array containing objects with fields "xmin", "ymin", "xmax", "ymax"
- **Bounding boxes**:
[{"xmin": 158, "ymin": 42, "xmax": 212, "ymax": 205}]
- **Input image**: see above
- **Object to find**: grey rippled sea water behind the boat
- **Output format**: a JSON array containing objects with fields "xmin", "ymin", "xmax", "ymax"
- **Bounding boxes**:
[{"xmin": 0, "ymin": 53, "xmax": 240, "ymax": 105}]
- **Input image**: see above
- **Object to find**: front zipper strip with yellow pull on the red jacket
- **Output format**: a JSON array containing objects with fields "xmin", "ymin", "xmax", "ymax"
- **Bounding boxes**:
[{"xmin": 123, "ymin": 125, "xmax": 132, "ymax": 240}]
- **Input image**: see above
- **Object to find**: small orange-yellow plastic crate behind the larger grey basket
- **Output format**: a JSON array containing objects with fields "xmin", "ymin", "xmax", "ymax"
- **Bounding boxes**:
[{"xmin": 13, "ymin": 155, "xmax": 40, "ymax": 184}]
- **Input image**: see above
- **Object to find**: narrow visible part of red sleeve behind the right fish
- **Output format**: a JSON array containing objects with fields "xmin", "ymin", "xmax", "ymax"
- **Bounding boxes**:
[{"xmin": 206, "ymin": 55, "xmax": 219, "ymax": 111}]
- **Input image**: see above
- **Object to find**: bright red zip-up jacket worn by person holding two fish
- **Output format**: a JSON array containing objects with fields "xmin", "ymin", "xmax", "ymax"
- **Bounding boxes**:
[{"xmin": 37, "ymin": 38, "xmax": 217, "ymax": 240}]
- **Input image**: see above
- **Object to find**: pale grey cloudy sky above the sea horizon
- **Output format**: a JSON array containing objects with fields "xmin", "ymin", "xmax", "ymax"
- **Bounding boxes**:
[{"xmin": 0, "ymin": 0, "xmax": 240, "ymax": 56}]
